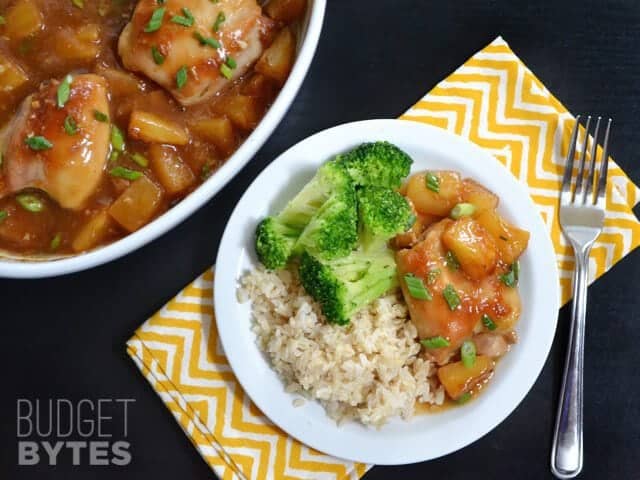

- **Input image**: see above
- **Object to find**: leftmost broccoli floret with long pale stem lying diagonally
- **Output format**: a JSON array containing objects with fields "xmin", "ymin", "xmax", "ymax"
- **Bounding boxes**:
[{"xmin": 256, "ymin": 162, "xmax": 356, "ymax": 270}]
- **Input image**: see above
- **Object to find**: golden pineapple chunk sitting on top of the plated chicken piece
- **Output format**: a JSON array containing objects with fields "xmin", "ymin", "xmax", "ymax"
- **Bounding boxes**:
[{"xmin": 442, "ymin": 217, "xmax": 498, "ymax": 280}]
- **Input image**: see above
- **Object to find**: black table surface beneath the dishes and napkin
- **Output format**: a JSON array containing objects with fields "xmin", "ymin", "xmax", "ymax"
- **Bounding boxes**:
[{"xmin": 0, "ymin": 0, "xmax": 640, "ymax": 480}]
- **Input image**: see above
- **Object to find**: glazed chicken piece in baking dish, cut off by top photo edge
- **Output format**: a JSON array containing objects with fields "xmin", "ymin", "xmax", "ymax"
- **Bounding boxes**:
[{"xmin": 118, "ymin": 0, "xmax": 271, "ymax": 105}]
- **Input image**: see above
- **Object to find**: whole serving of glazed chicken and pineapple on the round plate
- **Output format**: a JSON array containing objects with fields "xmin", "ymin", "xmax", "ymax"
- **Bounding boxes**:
[{"xmin": 394, "ymin": 171, "xmax": 529, "ymax": 401}]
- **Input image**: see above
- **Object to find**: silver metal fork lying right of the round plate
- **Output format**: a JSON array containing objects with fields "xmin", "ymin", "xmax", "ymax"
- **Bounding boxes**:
[{"xmin": 551, "ymin": 115, "xmax": 611, "ymax": 479}]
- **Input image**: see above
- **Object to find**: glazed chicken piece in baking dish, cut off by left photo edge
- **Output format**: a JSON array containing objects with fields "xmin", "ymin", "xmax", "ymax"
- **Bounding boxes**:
[{"xmin": 0, "ymin": 74, "xmax": 110, "ymax": 210}]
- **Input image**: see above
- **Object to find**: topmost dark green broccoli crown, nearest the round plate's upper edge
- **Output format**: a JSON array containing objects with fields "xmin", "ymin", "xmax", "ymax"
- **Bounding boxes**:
[{"xmin": 336, "ymin": 142, "xmax": 413, "ymax": 188}]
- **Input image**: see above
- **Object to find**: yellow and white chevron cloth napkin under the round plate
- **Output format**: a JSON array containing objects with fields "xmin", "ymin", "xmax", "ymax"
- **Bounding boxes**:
[{"xmin": 127, "ymin": 38, "xmax": 640, "ymax": 480}]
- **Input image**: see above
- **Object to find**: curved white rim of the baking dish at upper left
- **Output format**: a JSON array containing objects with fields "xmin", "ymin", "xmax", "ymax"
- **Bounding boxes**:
[{"xmin": 0, "ymin": 0, "xmax": 326, "ymax": 278}]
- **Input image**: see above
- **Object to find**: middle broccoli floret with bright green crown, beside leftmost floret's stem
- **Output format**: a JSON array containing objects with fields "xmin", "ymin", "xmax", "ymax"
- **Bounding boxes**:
[{"xmin": 294, "ymin": 185, "xmax": 358, "ymax": 260}]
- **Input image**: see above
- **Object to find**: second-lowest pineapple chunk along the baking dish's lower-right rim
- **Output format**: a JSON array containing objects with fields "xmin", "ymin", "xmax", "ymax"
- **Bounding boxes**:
[{"xmin": 109, "ymin": 176, "xmax": 162, "ymax": 232}]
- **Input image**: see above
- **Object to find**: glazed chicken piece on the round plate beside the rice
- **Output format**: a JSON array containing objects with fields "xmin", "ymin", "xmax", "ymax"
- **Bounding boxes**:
[{"xmin": 396, "ymin": 219, "xmax": 520, "ymax": 365}]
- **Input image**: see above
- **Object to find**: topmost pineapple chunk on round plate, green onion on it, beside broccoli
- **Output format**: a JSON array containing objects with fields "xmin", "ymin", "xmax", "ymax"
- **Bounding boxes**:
[{"xmin": 407, "ymin": 170, "xmax": 462, "ymax": 217}]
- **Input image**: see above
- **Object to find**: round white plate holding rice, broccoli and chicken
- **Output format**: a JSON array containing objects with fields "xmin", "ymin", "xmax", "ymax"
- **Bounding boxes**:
[{"xmin": 214, "ymin": 120, "xmax": 559, "ymax": 465}]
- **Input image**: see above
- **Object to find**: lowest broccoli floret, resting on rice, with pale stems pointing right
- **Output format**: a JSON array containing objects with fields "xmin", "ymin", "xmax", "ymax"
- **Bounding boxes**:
[{"xmin": 300, "ymin": 249, "xmax": 398, "ymax": 325}]
